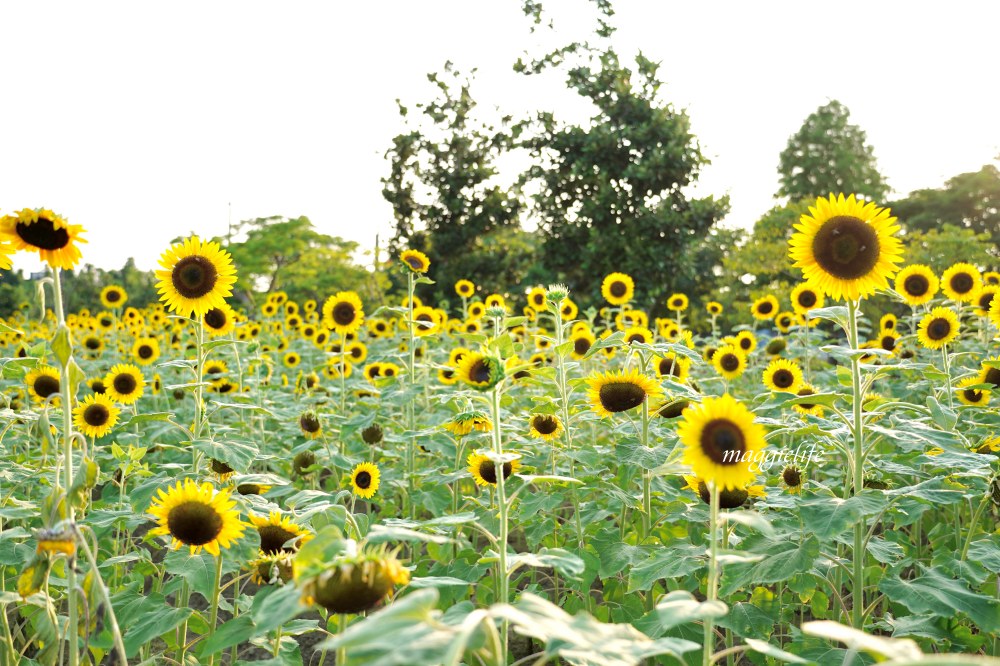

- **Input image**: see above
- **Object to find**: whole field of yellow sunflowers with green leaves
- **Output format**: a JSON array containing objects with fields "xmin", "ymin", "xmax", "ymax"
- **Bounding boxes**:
[{"xmin": 0, "ymin": 194, "xmax": 1000, "ymax": 666}]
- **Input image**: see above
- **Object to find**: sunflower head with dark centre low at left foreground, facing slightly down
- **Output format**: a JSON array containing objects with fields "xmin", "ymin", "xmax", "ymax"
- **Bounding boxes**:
[{"xmin": 148, "ymin": 479, "xmax": 246, "ymax": 556}]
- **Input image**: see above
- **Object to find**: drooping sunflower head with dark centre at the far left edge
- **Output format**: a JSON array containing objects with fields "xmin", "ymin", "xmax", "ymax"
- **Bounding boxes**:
[{"xmin": 0, "ymin": 208, "xmax": 87, "ymax": 270}]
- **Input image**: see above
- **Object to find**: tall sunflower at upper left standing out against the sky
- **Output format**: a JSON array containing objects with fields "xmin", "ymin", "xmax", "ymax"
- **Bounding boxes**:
[{"xmin": 156, "ymin": 236, "xmax": 236, "ymax": 318}]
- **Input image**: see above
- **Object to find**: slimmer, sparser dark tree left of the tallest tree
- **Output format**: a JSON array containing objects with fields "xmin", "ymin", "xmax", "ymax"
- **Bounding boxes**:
[{"xmin": 382, "ymin": 62, "xmax": 528, "ymax": 302}]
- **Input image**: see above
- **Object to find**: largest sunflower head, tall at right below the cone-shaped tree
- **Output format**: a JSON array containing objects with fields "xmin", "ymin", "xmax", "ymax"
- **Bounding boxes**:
[{"xmin": 789, "ymin": 194, "xmax": 903, "ymax": 301}]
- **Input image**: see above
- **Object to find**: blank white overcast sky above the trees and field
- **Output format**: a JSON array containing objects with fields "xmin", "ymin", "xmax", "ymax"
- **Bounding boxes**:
[{"xmin": 0, "ymin": 0, "xmax": 1000, "ymax": 270}]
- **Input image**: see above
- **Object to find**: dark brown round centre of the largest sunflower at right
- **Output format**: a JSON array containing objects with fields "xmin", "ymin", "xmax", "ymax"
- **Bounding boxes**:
[{"xmin": 812, "ymin": 215, "xmax": 879, "ymax": 280}]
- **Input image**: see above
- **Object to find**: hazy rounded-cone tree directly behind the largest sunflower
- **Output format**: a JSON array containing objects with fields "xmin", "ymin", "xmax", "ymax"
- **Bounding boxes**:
[{"xmin": 775, "ymin": 100, "xmax": 889, "ymax": 202}]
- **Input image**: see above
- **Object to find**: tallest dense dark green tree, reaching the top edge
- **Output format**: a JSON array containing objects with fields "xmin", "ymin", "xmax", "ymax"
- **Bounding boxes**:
[{"xmin": 515, "ymin": 2, "xmax": 729, "ymax": 305}]
